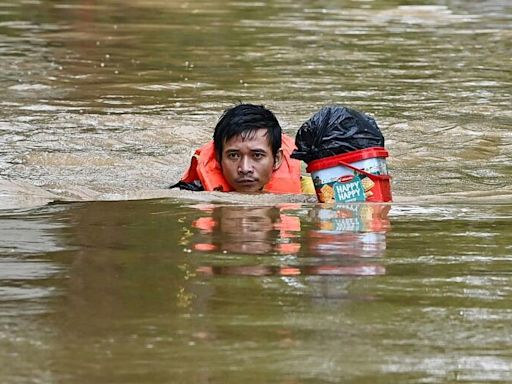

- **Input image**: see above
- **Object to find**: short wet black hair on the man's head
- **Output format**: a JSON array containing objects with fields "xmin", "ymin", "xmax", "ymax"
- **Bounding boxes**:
[{"xmin": 213, "ymin": 104, "xmax": 282, "ymax": 161}]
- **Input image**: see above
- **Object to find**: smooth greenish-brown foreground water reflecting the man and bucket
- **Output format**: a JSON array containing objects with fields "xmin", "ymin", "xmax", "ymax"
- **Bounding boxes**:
[{"xmin": 0, "ymin": 199, "xmax": 512, "ymax": 384}]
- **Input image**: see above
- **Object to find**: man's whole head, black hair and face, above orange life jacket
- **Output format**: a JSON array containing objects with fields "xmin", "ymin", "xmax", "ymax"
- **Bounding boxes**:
[{"xmin": 213, "ymin": 104, "xmax": 283, "ymax": 192}]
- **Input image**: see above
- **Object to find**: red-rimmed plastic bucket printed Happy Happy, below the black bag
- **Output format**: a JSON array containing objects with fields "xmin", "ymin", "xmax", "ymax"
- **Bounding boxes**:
[{"xmin": 306, "ymin": 147, "xmax": 391, "ymax": 203}]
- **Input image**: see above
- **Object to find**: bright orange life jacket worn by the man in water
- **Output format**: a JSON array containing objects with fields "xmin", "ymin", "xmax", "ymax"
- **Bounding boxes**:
[{"xmin": 181, "ymin": 135, "xmax": 301, "ymax": 193}]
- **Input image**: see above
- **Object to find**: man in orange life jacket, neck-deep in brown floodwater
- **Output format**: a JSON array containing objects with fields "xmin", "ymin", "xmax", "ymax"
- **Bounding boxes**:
[{"xmin": 175, "ymin": 104, "xmax": 301, "ymax": 193}]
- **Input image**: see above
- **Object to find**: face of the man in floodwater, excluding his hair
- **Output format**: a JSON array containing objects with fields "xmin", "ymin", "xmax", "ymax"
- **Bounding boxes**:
[{"xmin": 220, "ymin": 129, "xmax": 282, "ymax": 192}]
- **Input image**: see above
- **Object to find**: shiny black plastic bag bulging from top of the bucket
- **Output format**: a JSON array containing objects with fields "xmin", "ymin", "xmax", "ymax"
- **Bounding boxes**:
[{"xmin": 291, "ymin": 105, "xmax": 384, "ymax": 163}]
